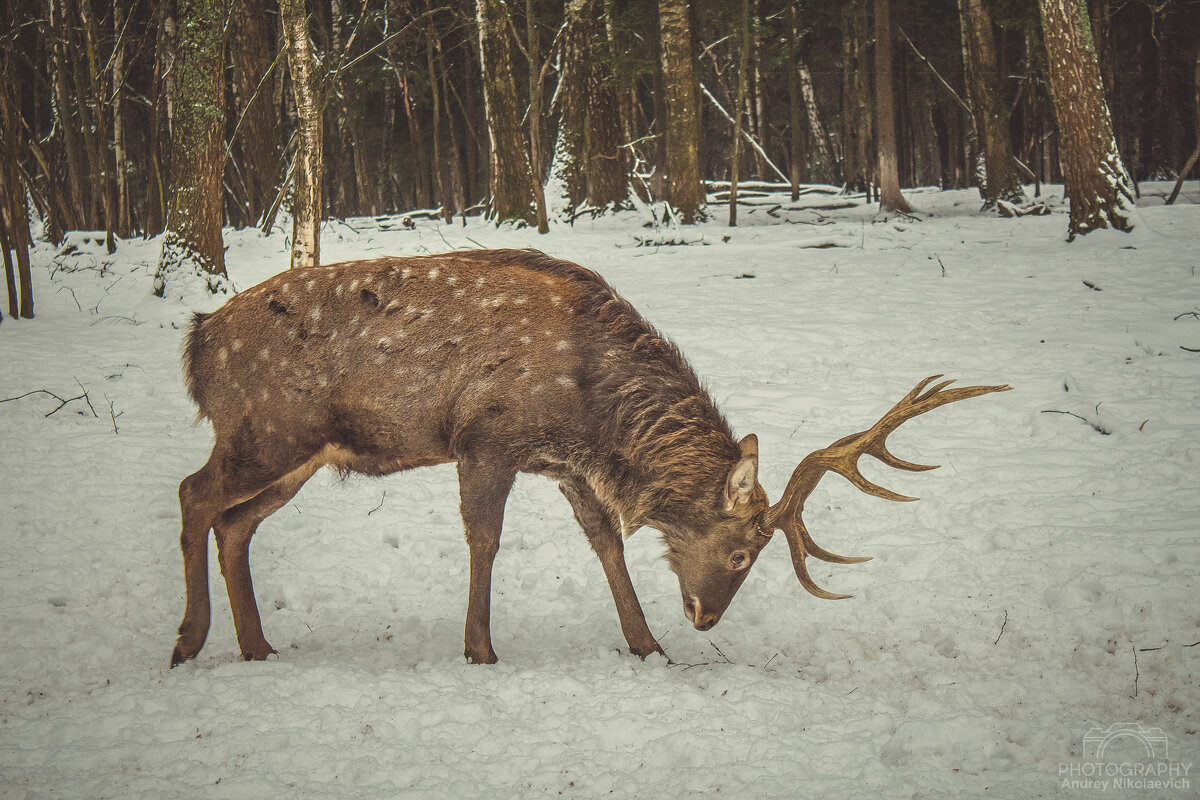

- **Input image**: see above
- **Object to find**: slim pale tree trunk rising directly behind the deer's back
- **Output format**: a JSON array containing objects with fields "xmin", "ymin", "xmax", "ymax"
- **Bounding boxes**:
[{"xmin": 280, "ymin": 0, "xmax": 324, "ymax": 269}]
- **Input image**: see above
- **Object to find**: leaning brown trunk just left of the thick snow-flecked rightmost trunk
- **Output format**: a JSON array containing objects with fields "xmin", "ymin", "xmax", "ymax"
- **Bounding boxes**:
[{"xmin": 959, "ymin": 0, "xmax": 1025, "ymax": 209}]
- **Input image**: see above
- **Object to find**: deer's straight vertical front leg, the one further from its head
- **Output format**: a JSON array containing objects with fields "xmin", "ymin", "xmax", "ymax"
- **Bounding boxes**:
[{"xmin": 458, "ymin": 462, "xmax": 516, "ymax": 664}]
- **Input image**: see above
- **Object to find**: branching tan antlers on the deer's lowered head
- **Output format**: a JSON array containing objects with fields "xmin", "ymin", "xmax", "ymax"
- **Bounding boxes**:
[{"xmin": 762, "ymin": 375, "xmax": 1012, "ymax": 600}]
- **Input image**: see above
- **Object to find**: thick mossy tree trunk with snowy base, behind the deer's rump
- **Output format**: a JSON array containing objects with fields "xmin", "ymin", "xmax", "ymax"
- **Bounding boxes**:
[{"xmin": 155, "ymin": 0, "xmax": 228, "ymax": 297}]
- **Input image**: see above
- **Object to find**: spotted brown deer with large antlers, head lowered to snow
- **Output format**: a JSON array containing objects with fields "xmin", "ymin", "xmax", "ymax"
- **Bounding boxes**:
[{"xmin": 170, "ymin": 249, "xmax": 1010, "ymax": 667}]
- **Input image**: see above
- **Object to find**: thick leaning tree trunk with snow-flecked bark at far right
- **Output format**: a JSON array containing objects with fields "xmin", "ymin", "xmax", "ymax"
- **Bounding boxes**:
[{"xmin": 1038, "ymin": 0, "xmax": 1133, "ymax": 241}]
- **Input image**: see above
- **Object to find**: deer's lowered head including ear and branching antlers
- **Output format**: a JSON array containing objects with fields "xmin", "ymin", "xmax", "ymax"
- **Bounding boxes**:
[{"xmin": 665, "ymin": 375, "xmax": 1012, "ymax": 631}]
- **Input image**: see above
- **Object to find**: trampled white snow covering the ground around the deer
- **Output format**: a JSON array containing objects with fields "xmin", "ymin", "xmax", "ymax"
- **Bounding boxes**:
[{"xmin": 0, "ymin": 184, "xmax": 1200, "ymax": 800}]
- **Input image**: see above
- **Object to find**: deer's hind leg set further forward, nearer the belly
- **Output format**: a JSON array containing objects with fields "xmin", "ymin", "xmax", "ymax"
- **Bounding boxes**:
[{"xmin": 212, "ymin": 458, "xmax": 322, "ymax": 661}]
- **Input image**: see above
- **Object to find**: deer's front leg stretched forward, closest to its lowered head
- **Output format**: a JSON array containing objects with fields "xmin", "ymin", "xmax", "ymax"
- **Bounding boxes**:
[{"xmin": 558, "ymin": 480, "xmax": 666, "ymax": 658}]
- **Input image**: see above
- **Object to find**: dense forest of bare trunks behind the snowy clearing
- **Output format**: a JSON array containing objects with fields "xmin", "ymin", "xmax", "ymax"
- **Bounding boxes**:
[{"xmin": 0, "ymin": 0, "xmax": 1200, "ymax": 317}]
